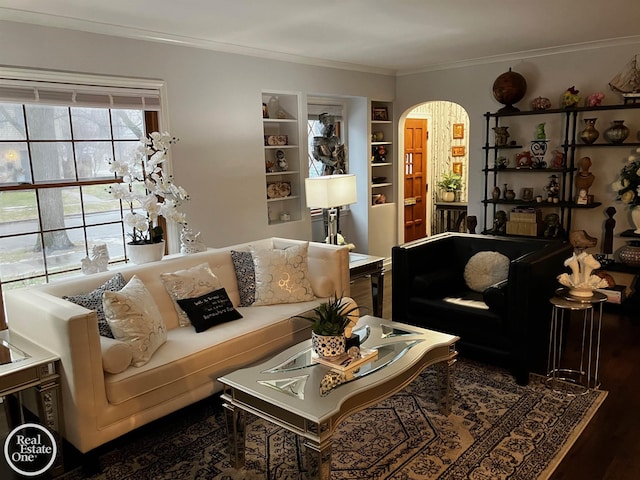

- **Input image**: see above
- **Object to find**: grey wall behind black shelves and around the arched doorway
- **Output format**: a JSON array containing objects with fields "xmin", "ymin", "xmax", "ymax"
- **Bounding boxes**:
[{"xmin": 395, "ymin": 43, "xmax": 640, "ymax": 255}]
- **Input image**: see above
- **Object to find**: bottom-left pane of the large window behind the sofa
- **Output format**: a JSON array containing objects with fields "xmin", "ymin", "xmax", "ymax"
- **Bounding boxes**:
[{"xmin": 0, "ymin": 234, "xmax": 44, "ymax": 288}]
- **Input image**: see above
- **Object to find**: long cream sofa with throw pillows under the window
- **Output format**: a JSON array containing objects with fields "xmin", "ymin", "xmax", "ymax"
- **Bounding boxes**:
[{"xmin": 5, "ymin": 238, "xmax": 349, "ymax": 453}]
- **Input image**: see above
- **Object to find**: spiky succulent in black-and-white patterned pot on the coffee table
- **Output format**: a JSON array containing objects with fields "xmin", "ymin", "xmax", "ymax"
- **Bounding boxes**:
[{"xmin": 301, "ymin": 294, "xmax": 358, "ymax": 357}]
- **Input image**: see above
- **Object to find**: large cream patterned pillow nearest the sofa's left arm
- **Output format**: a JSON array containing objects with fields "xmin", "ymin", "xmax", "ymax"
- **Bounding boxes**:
[{"xmin": 102, "ymin": 275, "xmax": 167, "ymax": 367}]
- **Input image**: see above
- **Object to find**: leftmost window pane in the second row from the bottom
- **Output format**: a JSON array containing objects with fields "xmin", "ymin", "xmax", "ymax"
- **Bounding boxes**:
[{"xmin": 0, "ymin": 190, "xmax": 40, "ymax": 232}]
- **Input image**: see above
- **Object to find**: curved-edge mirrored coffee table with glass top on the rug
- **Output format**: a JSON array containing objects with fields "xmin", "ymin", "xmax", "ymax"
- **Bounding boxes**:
[{"xmin": 218, "ymin": 315, "xmax": 459, "ymax": 480}]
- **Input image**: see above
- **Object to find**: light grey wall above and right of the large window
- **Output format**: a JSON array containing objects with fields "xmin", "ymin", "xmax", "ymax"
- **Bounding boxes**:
[{"xmin": 0, "ymin": 21, "xmax": 395, "ymax": 246}]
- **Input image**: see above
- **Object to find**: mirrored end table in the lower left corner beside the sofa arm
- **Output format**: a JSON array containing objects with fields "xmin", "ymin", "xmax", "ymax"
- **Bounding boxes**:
[{"xmin": 0, "ymin": 330, "xmax": 64, "ymax": 476}]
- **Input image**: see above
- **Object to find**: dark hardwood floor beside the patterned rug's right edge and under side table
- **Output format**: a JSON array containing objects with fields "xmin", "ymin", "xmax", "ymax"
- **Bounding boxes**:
[{"xmin": 351, "ymin": 272, "xmax": 640, "ymax": 480}]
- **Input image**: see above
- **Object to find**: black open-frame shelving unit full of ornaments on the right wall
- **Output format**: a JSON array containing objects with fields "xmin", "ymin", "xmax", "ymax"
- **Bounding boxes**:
[{"xmin": 482, "ymin": 104, "xmax": 640, "ymax": 237}]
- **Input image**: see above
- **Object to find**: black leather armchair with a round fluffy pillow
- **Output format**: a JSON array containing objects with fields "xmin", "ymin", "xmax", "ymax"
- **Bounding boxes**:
[{"xmin": 391, "ymin": 233, "xmax": 573, "ymax": 385}]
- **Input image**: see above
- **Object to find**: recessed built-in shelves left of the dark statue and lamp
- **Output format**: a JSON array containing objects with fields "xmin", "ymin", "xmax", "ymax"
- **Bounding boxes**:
[{"xmin": 262, "ymin": 92, "xmax": 304, "ymax": 225}]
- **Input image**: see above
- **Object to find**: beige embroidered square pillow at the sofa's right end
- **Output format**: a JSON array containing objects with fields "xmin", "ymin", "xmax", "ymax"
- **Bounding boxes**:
[{"xmin": 251, "ymin": 243, "xmax": 315, "ymax": 305}]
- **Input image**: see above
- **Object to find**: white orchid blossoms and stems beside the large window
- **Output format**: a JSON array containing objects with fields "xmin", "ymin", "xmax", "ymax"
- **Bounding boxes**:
[{"xmin": 109, "ymin": 132, "xmax": 189, "ymax": 245}]
